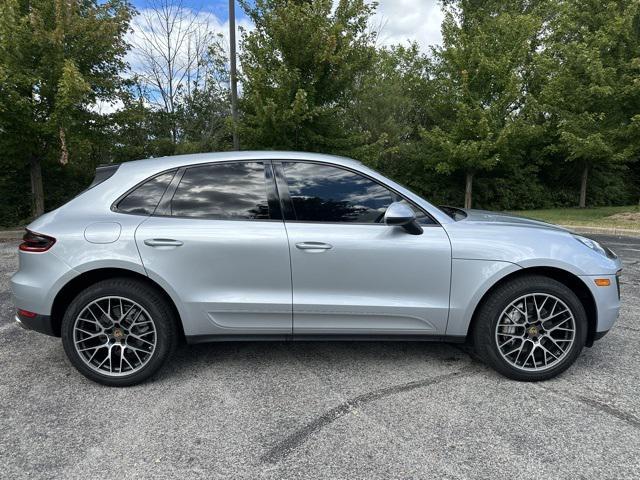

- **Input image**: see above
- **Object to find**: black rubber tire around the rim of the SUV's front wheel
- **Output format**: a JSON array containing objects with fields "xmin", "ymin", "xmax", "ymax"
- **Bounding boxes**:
[{"xmin": 472, "ymin": 275, "xmax": 588, "ymax": 382}]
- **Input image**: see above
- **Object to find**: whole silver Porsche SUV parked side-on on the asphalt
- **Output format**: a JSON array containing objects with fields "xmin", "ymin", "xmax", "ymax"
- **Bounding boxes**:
[{"xmin": 11, "ymin": 152, "xmax": 621, "ymax": 386}]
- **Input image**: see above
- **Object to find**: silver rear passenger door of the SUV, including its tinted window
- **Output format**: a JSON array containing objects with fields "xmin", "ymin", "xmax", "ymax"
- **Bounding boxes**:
[{"xmin": 136, "ymin": 161, "xmax": 292, "ymax": 336}]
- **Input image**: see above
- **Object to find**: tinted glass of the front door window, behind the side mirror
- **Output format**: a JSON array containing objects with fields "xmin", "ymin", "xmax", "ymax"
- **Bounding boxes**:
[{"xmin": 284, "ymin": 162, "xmax": 400, "ymax": 223}]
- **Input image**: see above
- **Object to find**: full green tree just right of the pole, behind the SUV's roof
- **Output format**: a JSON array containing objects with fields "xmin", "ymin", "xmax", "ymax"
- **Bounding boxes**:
[{"xmin": 240, "ymin": 0, "xmax": 375, "ymax": 152}]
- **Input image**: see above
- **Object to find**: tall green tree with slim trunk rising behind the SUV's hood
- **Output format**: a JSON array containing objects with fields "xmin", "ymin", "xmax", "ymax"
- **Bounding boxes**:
[{"xmin": 423, "ymin": 0, "xmax": 542, "ymax": 208}]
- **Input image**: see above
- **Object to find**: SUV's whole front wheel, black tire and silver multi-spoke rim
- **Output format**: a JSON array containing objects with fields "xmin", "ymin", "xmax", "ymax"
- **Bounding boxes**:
[{"xmin": 473, "ymin": 275, "xmax": 587, "ymax": 381}]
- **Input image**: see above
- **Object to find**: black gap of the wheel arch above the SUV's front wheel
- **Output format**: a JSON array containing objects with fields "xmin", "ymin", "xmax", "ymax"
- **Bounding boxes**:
[{"xmin": 467, "ymin": 267, "xmax": 598, "ymax": 347}]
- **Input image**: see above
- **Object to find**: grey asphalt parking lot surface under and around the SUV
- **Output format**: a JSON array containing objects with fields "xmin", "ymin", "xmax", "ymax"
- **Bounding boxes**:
[{"xmin": 0, "ymin": 236, "xmax": 640, "ymax": 479}]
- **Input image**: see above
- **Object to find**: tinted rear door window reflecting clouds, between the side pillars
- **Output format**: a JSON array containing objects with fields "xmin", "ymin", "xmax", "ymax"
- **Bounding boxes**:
[{"xmin": 171, "ymin": 162, "xmax": 269, "ymax": 220}]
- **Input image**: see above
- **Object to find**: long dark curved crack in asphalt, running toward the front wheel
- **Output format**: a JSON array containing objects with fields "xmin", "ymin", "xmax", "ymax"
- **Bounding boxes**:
[{"xmin": 261, "ymin": 367, "xmax": 475, "ymax": 463}]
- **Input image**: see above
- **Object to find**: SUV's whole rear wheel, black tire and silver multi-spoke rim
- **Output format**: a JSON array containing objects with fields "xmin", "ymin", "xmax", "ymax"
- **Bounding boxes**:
[{"xmin": 61, "ymin": 278, "xmax": 177, "ymax": 387}]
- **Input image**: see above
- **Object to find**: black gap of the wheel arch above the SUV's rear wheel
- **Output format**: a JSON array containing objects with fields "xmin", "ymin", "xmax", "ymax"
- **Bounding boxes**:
[{"xmin": 51, "ymin": 268, "xmax": 185, "ymax": 339}]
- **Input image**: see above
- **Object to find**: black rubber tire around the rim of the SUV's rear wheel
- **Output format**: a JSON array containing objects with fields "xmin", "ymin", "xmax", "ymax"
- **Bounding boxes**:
[{"xmin": 61, "ymin": 278, "xmax": 178, "ymax": 387}]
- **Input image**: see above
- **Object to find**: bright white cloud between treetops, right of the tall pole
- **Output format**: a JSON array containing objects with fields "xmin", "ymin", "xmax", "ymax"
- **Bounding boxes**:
[{"xmin": 371, "ymin": 0, "xmax": 444, "ymax": 52}]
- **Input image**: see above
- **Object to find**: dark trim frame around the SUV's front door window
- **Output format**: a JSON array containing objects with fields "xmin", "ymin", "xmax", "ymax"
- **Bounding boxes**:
[{"xmin": 272, "ymin": 160, "xmax": 441, "ymax": 227}]
